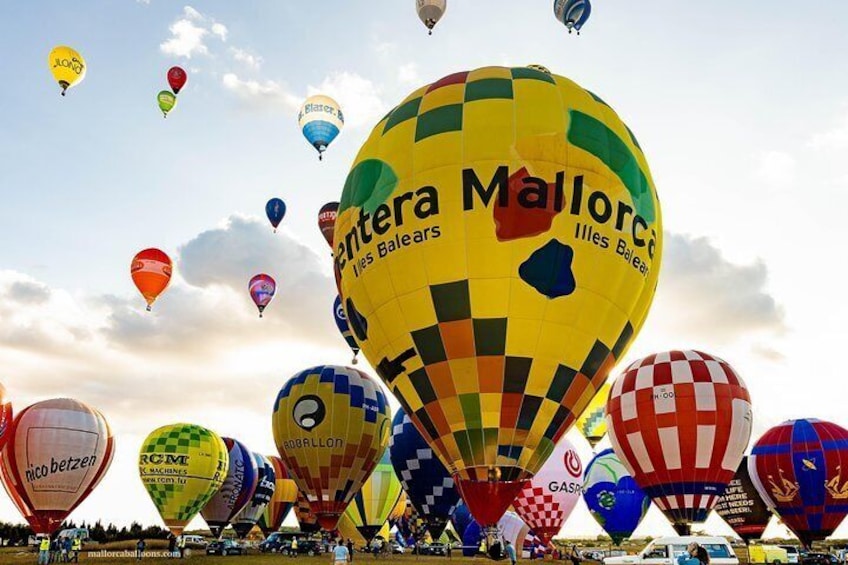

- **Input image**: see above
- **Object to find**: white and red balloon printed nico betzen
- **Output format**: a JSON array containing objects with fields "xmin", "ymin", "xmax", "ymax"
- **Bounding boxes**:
[{"xmin": 0, "ymin": 398, "xmax": 115, "ymax": 534}]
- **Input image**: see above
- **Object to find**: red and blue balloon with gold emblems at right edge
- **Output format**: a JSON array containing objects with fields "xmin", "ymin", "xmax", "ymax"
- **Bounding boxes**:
[{"xmin": 748, "ymin": 418, "xmax": 848, "ymax": 548}]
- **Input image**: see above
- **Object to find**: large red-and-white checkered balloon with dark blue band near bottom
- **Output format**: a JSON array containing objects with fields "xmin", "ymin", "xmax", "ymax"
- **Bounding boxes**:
[{"xmin": 607, "ymin": 351, "xmax": 751, "ymax": 535}]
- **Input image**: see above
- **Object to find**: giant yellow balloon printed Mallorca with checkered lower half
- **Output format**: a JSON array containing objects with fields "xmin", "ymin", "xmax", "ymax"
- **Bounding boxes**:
[{"xmin": 333, "ymin": 67, "xmax": 662, "ymax": 525}]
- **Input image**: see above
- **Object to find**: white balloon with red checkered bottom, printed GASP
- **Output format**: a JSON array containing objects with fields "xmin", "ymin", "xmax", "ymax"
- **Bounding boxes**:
[{"xmin": 512, "ymin": 438, "xmax": 583, "ymax": 545}]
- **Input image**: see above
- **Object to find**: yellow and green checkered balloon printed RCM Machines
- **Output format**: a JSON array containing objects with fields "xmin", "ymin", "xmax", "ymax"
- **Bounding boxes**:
[{"xmin": 138, "ymin": 424, "xmax": 230, "ymax": 536}]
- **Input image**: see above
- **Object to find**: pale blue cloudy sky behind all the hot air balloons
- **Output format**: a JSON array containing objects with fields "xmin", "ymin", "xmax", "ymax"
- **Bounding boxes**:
[{"xmin": 0, "ymin": 0, "xmax": 848, "ymax": 535}]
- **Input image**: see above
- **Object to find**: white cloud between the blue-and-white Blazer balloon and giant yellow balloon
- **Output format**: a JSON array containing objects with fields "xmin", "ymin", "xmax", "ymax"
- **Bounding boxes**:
[{"xmin": 308, "ymin": 71, "xmax": 388, "ymax": 128}]
